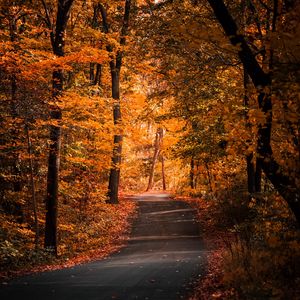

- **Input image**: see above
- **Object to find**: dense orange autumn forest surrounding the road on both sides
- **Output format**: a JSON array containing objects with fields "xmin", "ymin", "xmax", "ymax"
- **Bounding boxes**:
[{"xmin": 0, "ymin": 0, "xmax": 300, "ymax": 299}]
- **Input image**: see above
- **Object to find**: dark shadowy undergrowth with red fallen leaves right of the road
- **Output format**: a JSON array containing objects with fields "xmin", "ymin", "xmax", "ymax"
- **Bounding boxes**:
[{"xmin": 181, "ymin": 176, "xmax": 300, "ymax": 300}]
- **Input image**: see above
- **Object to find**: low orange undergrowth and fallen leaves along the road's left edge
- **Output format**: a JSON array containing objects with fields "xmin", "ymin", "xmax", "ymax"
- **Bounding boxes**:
[{"xmin": 0, "ymin": 199, "xmax": 135, "ymax": 279}]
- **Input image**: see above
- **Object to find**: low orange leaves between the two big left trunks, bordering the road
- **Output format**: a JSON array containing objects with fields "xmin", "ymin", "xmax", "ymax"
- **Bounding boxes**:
[{"xmin": 59, "ymin": 197, "xmax": 135, "ymax": 256}]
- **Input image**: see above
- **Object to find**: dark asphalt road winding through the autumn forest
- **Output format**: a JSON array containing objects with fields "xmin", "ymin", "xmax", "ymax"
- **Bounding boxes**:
[{"xmin": 0, "ymin": 193, "xmax": 206, "ymax": 300}]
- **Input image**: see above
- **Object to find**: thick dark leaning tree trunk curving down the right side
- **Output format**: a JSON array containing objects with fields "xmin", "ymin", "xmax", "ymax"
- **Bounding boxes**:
[{"xmin": 208, "ymin": 0, "xmax": 300, "ymax": 224}]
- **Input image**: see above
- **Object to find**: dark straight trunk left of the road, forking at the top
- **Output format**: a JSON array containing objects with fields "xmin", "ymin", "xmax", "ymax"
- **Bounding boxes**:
[{"xmin": 42, "ymin": 0, "xmax": 74, "ymax": 255}]
